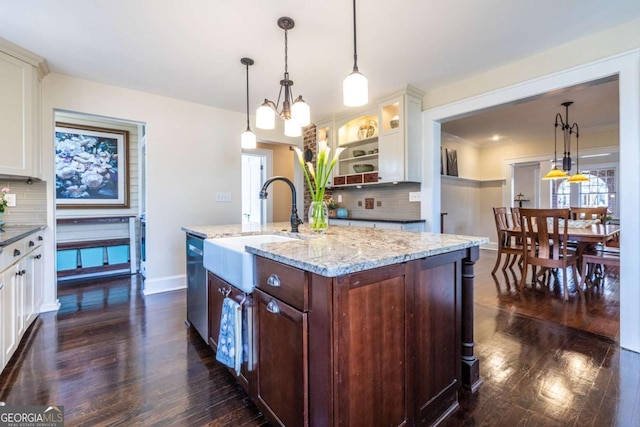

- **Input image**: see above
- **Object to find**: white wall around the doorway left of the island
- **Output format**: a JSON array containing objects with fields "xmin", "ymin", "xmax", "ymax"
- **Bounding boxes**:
[{"xmin": 42, "ymin": 74, "xmax": 246, "ymax": 300}]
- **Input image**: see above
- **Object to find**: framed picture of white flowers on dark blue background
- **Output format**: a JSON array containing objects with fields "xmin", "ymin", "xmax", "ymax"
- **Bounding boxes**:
[{"xmin": 55, "ymin": 123, "xmax": 129, "ymax": 209}]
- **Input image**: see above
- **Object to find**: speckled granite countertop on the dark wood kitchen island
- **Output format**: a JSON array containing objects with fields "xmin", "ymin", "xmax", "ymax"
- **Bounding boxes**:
[{"xmin": 182, "ymin": 223, "xmax": 489, "ymax": 277}]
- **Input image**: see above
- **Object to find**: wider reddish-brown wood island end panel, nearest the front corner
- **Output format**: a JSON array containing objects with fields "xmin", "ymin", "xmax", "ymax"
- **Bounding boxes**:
[{"xmin": 334, "ymin": 264, "xmax": 411, "ymax": 426}]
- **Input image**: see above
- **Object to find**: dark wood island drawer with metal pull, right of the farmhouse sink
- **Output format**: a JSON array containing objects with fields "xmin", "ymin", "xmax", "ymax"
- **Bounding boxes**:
[{"xmin": 255, "ymin": 257, "xmax": 309, "ymax": 312}]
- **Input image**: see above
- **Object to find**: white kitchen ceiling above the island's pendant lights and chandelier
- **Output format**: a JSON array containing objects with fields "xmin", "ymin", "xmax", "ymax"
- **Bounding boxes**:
[{"xmin": 0, "ymin": 0, "xmax": 640, "ymax": 131}]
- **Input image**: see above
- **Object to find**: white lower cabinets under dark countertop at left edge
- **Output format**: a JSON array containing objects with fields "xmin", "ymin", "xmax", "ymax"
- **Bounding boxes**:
[{"xmin": 0, "ymin": 232, "xmax": 43, "ymax": 371}]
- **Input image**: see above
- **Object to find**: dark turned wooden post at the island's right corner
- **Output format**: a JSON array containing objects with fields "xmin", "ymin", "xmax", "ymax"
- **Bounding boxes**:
[{"xmin": 461, "ymin": 246, "xmax": 482, "ymax": 393}]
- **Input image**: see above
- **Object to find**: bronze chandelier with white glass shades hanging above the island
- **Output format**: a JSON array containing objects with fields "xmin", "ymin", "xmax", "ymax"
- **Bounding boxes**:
[{"xmin": 256, "ymin": 17, "xmax": 311, "ymax": 136}]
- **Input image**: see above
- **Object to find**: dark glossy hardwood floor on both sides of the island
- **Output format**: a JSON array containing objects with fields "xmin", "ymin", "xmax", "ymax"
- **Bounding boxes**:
[{"xmin": 0, "ymin": 251, "xmax": 640, "ymax": 427}]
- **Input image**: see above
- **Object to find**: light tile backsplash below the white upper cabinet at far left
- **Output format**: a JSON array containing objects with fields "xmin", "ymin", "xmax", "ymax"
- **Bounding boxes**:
[{"xmin": 0, "ymin": 178, "xmax": 47, "ymax": 225}]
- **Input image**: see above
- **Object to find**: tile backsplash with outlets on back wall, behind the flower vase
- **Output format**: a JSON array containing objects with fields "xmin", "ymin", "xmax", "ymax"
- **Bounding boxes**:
[{"xmin": 333, "ymin": 183, "xmax": 420, "ymax": 220}]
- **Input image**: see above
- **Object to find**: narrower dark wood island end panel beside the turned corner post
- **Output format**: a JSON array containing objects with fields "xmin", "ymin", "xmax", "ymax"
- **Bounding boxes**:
[{"xmin": 412, "ymin": 252, "xmax": 462, "ymax": 425}]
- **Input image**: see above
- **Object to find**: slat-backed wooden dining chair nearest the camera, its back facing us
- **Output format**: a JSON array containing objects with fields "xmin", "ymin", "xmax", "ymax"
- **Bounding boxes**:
[{"xmin": 520, "ymin": 208, "xmax": 582, "ymax": 301}]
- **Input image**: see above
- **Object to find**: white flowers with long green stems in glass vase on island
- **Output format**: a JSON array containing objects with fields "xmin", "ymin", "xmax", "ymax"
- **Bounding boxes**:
[{"xmin": 293, "ymin": 141, "xmax": 344, "ymax": 233}]
